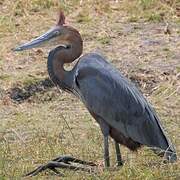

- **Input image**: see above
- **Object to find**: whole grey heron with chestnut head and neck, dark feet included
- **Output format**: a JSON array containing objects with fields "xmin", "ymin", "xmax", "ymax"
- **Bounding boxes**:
[{"xmin": 14, "ymin": 12, "xmax": 177, "ymax": 175}]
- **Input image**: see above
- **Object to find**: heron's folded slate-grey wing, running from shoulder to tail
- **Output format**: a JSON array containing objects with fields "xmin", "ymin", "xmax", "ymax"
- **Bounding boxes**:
[{"xmin": 76, "ymin": 52, "xmax": 173, "ymax": 149}]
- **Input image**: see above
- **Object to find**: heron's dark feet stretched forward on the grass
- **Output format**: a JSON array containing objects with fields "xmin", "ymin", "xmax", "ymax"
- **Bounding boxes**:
[{"xmin": 25, "ymin": 156, "xmax": 96, "ymax": 176}]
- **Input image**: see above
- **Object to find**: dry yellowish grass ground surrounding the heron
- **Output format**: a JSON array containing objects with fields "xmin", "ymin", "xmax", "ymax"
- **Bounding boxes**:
[{"xmin": 0, "ymin": 0, "xmax": 180, "ymax": 179}]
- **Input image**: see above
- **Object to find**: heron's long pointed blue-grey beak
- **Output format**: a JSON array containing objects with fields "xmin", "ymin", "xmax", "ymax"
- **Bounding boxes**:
[{"xmin": 12, "ymin": 26, "xmax": 61, "ymax": 51}]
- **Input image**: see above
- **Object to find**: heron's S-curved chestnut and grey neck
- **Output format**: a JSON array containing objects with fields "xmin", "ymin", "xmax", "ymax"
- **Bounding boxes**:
[{"xmin": 48, "ymin": 28, "xmax": 83, "ymax": 92}]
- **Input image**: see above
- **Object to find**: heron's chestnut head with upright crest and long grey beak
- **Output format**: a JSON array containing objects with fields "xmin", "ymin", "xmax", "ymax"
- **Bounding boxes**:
[{"xmin": 13, "ymin": 12, "xmax": 82, "ymax": 55}]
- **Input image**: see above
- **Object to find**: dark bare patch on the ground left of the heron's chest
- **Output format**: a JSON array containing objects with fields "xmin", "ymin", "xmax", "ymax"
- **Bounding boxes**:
[{"xmin": 7, "ymin": 78, "xmax": 54, "ymax": 103}]
